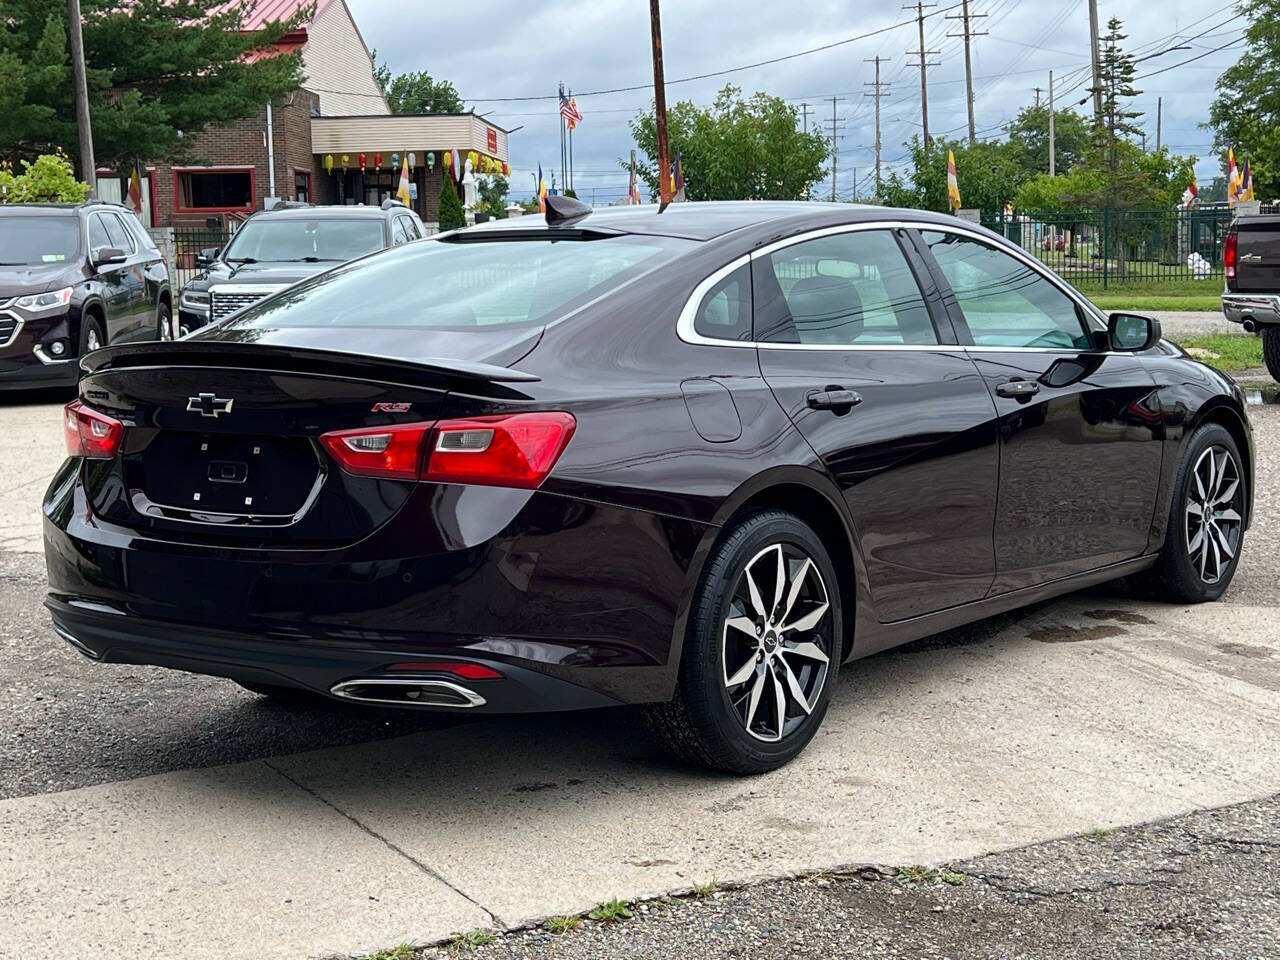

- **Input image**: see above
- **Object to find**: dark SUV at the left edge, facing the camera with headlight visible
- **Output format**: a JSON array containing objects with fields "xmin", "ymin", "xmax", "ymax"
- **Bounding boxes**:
[{"xmin": 0, "ymin": 202, "xmax": 173, "ymax": 388}]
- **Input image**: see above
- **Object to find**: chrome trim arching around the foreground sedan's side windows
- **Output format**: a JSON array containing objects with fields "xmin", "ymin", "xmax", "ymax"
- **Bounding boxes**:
[{"xmin": 676, "ymin": 219, "xmax": 1111, "ymax": 356}]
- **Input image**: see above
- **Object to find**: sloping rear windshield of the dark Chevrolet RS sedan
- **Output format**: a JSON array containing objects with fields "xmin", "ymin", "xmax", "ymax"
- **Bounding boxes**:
[{"xmin": 225, "ymin": 237, "xmax": 696, "ymax": 329}]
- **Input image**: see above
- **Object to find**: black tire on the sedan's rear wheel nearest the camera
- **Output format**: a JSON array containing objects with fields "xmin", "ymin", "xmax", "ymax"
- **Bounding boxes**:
[{"xmin": 645, "ymin": 511, "xmax": 844, "ymax": 773}]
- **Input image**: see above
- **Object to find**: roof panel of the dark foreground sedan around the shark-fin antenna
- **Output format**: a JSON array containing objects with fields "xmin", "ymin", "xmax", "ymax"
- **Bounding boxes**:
[{"xmin": 467, "ymin": 200, "xmax": 972, "ymax": 241}]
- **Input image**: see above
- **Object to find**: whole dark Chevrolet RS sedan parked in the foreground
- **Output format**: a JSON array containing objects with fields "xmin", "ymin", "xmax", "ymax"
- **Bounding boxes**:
[{"xmin": 44, "ymin": 197, "xmax": 1253, "ymax": 772}]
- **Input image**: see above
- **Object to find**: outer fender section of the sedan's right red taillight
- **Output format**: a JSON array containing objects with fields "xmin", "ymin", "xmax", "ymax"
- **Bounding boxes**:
[{"xmin": 424, "ymin": 413, "xmax": 577, "ymax": 489}]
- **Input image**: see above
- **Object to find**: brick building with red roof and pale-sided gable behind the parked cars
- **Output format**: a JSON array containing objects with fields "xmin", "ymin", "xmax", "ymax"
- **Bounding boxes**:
[{"xmin": 99, "ymin": 0, "xmax": 508, "ymax": 229}]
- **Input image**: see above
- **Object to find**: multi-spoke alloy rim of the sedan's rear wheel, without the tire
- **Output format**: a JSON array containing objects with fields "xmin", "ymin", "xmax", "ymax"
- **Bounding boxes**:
[{"xmin": 721, "ymin": 543, "xmax": 832, "ymax": 742}]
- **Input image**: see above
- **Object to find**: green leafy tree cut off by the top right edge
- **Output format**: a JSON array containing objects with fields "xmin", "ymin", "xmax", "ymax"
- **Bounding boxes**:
[{"xmin": 1206, "ymin": 0, "xmax": 1280, "ymax": 198}]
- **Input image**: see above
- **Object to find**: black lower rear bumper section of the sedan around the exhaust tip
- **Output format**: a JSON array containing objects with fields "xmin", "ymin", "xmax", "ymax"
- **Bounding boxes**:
[{"xmin": 45, "ymin": 596, "xmax": 618, "ymax": 713}]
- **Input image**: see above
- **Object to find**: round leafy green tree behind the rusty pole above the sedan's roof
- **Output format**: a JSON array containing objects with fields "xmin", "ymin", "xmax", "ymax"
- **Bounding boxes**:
[{"xmin": 618, "ymin": 84, "xmax": 829, "ymax": 200}]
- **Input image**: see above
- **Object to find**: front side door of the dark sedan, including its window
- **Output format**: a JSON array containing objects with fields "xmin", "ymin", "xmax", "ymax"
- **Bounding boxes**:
[{"xmin": 918, "ymin": 228, "xmax": 1164, "ymax": 593}]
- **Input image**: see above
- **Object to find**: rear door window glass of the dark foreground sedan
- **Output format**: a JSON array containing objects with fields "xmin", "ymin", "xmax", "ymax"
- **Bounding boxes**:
[{"xmin": 753, "ymin": 230, "xmax": 938, "ymax": 346}]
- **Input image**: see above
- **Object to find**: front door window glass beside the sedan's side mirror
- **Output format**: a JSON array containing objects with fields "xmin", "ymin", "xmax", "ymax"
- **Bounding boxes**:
[{"xmin": 920, "ymin": 230, "xmax": 1092, "ymax": 349}]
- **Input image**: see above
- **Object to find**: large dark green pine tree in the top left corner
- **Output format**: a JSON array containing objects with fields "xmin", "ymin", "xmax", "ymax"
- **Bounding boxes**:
[{"xmin": 0, "ymin": 0, "xmax": 314, "ymax": 166}]
